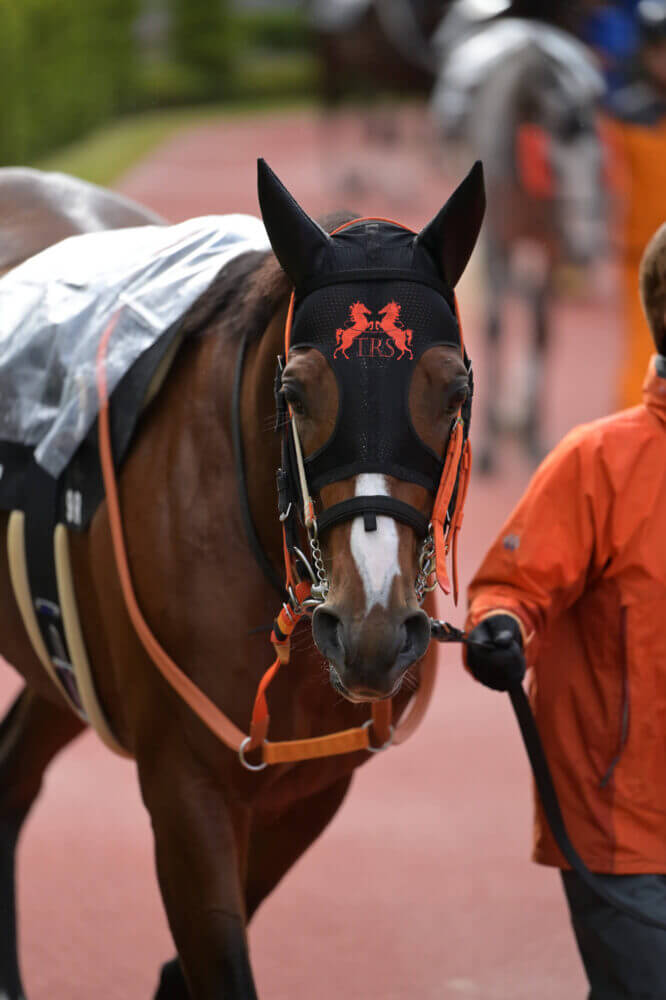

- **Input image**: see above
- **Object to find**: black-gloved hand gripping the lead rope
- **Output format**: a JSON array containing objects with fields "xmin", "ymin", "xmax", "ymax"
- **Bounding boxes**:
[{"xmin": 466, "ymin": 614, "xmax": 525, "ymax": 691}]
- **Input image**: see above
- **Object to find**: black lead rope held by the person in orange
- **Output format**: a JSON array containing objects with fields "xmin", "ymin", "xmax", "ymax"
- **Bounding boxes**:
[{"xmin": 431, "ymin": 619, "xmax": 666, "ymax": 931}]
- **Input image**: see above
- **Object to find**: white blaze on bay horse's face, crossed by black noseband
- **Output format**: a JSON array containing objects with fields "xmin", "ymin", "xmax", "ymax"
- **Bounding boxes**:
[{"xmin": 351, "ymin": 472, "xmax": 399, "ymax": 609}]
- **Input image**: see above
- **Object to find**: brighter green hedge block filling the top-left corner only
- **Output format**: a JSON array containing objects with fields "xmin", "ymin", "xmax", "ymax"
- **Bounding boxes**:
[{"xmin": 0, "ymin": 0, "xmax": 138, "ymax": 164}]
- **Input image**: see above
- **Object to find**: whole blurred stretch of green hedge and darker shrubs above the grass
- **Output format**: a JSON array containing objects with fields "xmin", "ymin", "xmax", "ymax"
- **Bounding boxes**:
[{"xmin": 0, "ymin": 0, "xmax": 316, "ymax": 165}]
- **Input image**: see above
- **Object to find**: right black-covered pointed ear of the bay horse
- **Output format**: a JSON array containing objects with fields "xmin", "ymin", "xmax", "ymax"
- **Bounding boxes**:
[{"xmin": 416, "ymin": 160, "xmax": 486, "ymax": 288}]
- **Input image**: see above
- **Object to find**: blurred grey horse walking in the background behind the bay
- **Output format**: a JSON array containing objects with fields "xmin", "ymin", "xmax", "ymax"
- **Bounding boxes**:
[{"xmin": 433, "ymin": 15, "xmax": 608, "ymax": 472}]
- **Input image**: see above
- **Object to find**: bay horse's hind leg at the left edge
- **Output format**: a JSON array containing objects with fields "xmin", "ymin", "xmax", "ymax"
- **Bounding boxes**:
[{"xmin": 0, "ymin": 688, "xmax": 85, "ymax": 1000}]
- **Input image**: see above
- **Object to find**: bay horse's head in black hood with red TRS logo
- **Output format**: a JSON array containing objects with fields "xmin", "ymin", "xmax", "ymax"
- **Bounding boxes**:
[{"xmin": 259, "ymin": 161, "xmax": 485, "ymax": 701}]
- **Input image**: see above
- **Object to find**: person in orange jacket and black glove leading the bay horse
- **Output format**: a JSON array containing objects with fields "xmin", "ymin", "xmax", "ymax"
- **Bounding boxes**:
[{"xmin": 466, "ymin": 225, "xmax": 666, "ymax": 1000}]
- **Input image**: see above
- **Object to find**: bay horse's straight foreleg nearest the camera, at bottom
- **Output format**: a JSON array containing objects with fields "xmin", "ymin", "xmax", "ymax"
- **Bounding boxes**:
[{"xmin": 137, "ymin": 748, "xmax": 257, "ymax": 1000}]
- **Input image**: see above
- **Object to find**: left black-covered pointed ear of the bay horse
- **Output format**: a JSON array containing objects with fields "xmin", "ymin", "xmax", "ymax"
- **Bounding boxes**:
[{"xmin": 257, "ymin": 159, "xmax": 330, "ymax": 285}]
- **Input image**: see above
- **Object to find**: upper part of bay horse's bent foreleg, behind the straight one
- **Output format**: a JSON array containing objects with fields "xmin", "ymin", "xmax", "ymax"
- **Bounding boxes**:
[{"xmin": 245, "ymin": 775, "xmax": 351, "ymax": 921}]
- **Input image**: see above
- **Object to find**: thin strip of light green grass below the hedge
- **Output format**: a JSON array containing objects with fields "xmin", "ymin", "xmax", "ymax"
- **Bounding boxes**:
[{"xmin": 32, "ymin": 98, "xmax": 311, "ymax": 186}]
